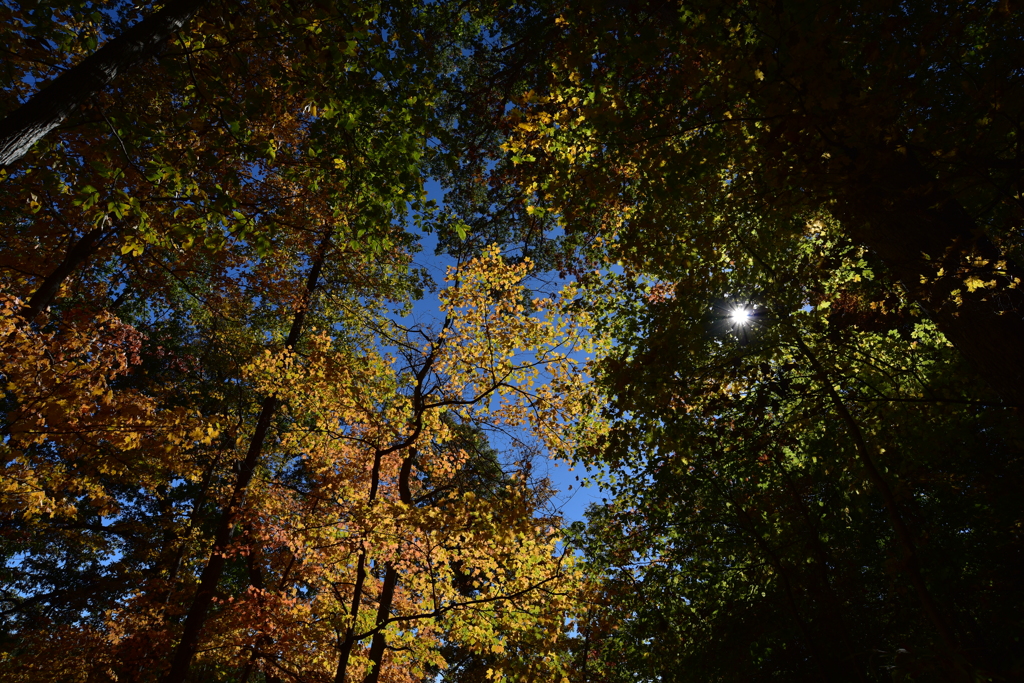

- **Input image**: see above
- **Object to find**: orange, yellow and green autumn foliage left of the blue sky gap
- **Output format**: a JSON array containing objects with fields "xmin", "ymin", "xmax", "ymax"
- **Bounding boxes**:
[{"xmin": 0, "ymin": 4, "xmax": 599, "ymax": 682}]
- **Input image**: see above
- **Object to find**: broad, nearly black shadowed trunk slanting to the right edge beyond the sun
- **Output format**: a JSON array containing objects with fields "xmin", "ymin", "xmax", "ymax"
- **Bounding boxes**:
[{"xmin": 833, "ymin": 151, "xmax": 1024, "ymax": 408}]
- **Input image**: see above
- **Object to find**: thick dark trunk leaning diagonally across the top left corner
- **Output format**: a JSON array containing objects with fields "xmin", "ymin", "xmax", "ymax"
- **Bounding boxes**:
[{"xmin": 0, "ymin": 0, "xmax": 207, "ymax": 168}]
